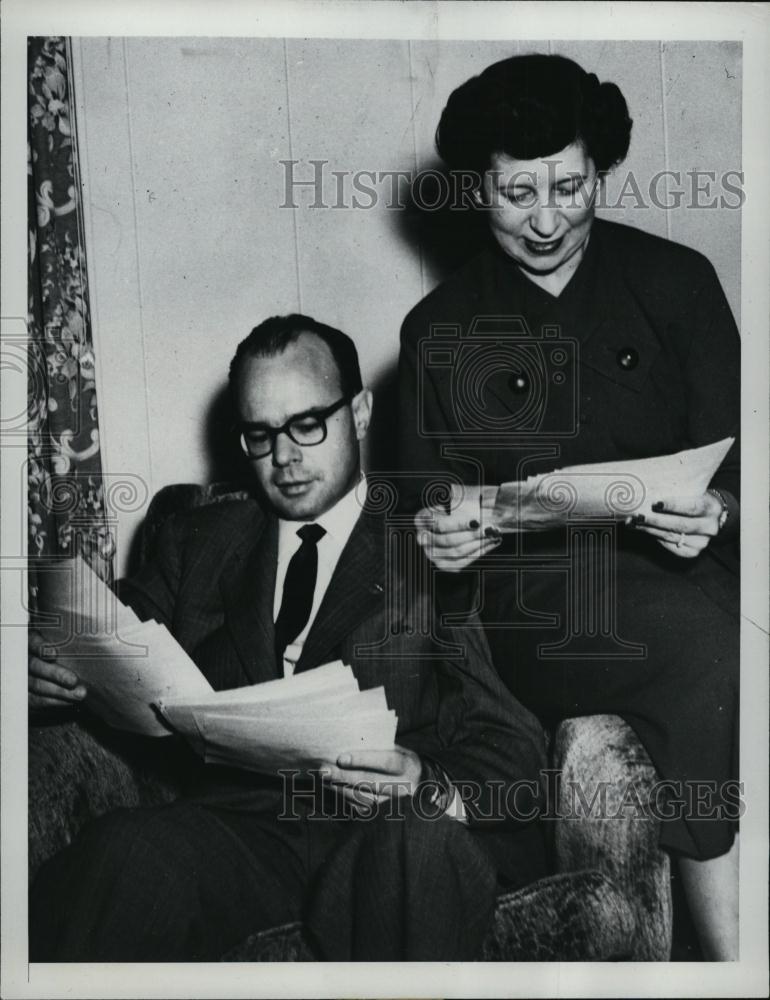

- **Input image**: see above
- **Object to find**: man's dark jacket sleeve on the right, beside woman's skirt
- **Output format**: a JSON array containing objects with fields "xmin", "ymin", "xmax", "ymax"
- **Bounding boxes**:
[{"xmin": 398, "ymin": 619, "xmax": 546, "ymax": 825}]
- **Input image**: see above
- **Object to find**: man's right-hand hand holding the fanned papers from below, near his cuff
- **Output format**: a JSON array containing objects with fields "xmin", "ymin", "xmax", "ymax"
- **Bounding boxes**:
[{"xmin": 319, "ymin": 746, "xmax": 422, "ymax": 811}]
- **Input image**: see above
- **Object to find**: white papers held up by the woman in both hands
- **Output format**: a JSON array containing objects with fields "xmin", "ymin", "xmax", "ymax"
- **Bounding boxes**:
[{"xmin": 493, "ymin": 437, "xmax": 735, "ymax": 531}]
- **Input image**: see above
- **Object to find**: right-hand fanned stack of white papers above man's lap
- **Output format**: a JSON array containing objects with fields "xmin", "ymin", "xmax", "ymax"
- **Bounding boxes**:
[{"xmin": 160, "ymin": 661, "xmax": 397, "ymax": 773}]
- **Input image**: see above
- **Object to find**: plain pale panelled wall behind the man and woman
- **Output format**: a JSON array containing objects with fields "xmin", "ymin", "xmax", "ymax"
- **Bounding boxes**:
[{"xmin": 74, "ymin": 38, "xmax": 741, "ymax": 573}]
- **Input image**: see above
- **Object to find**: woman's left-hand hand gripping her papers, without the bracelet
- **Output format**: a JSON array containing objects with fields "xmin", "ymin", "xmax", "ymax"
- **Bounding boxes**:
[{"xmin": 414, "ymin": 507, "xmax": 502, "ymax": 573}]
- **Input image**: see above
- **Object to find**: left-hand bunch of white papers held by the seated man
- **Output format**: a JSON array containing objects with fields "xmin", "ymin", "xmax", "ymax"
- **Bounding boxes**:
[{"xmin": 35, "ymin": 557, "xmax": 213, "ymax": 736}]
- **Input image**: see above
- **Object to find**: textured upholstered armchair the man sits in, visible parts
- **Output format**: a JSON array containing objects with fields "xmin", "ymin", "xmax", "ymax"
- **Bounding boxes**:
[{"xmin": 29, "ymin": 485, "xmax": 672, "ymax": 962}]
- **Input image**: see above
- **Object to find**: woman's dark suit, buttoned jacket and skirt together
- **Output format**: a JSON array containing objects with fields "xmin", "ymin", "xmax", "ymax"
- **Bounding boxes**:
[{"xmin": 399, "ymin": 220, "xmax": 740, "ymax": 857}]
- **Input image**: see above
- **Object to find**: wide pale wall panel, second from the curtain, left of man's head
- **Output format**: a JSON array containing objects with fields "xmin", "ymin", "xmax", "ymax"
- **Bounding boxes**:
[{"xmin": 127, "ymin": 38, "xmax": 298, "ymax": 488}]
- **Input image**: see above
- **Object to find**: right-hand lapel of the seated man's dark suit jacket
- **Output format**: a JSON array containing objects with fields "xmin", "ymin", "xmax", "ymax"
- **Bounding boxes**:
[{"xmin": 296, "ymin": 510, "xmax": 385, "ymax": 673}]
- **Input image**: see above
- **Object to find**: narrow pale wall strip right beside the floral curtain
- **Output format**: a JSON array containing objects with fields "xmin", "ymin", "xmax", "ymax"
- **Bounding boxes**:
[{"xmin": 73, "ymin": 38, "xmax": 152, "ymax": 565}]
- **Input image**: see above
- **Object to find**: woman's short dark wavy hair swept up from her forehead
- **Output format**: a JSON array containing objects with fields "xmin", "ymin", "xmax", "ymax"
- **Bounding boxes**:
[{"xmin": 436, "ymin": 55, "xmax": 632, "ymax": 174}]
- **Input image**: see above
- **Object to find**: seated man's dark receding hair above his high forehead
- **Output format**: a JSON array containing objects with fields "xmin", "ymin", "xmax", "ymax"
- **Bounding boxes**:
[{"xmin": 229, "ymin": 313, "xmax": 363, "ymax": 405}]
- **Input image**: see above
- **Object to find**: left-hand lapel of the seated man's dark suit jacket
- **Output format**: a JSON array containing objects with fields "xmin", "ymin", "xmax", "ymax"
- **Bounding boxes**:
[{"xmin": 222, "ymin": 516, "xmax": 279, "ymax": 684}]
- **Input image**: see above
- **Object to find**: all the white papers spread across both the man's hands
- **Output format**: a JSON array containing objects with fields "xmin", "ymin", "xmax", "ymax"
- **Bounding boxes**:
[{"xmin": 34, "ymin": 558, "xmax": 397, "ymax": 773}]
